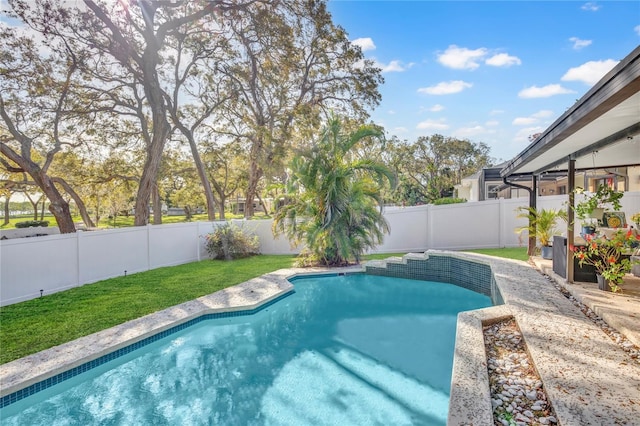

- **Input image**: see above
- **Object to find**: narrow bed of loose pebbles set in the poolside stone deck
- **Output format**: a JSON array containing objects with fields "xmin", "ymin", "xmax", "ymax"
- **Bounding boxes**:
[{"xmin": 484, "ymin": 319, "xmax": 557, "ymax": 426}]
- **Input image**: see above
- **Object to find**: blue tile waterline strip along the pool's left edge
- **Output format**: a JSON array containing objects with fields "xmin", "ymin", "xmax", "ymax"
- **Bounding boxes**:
[{"xmin": 0, "ymin": 290, "xmax": 293, "ymax": 408}]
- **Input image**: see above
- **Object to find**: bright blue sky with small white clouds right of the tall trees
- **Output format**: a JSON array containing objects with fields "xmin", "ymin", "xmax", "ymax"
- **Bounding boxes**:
[{"xmin": 328, "ymin": 0, "xmax": 640, "ymax": 162}]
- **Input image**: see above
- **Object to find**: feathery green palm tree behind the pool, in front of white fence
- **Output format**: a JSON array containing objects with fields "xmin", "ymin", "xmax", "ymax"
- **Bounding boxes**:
[{"xmin": 273, "ymin": 116, "xmax": 395, "ymax": 266}]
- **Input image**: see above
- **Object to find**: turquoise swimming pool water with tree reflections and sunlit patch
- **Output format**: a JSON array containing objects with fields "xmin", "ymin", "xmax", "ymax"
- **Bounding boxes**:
[{"xmin": 0, "ymin": 274, "xmax": 491, "ymax": 426}]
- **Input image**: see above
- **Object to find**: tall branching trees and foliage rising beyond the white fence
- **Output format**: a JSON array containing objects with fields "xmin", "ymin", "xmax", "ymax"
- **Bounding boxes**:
[{"xmin": 0, "ymin": 0, "xmax": 491, "ymax": 232}]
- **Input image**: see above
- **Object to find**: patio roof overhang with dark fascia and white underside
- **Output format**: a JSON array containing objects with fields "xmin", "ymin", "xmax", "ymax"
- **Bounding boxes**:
[{"xmin": 500, "ymin": 46, "xmax": 640, "ymax": 178}]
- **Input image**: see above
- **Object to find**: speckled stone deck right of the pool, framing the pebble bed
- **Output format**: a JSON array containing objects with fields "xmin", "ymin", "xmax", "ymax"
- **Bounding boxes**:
[{"xmin": 439, "ymin": 252, "xmax": 640, "ymax": 426}]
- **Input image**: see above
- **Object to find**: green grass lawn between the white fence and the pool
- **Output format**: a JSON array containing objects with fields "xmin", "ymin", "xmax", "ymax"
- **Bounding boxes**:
[{"xmin": 0, "ymin": 248, "xmax": 527, "ymax": 364}]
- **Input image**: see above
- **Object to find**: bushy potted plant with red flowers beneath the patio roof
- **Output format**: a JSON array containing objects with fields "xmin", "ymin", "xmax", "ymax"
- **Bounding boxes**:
[{"xmin": 570, "ymin": 229, "xmax": 640, "ymax": 292}]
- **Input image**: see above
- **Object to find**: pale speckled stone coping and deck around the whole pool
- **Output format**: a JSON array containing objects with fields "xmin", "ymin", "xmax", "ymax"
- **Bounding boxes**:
[{"xmin": 0, "ymin": 250, "xmax": 640, "ymax": 426}]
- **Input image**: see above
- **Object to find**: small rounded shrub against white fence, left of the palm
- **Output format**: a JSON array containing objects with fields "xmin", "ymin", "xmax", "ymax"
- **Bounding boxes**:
[{"xmin": 204, "ymin": 223, "xmax": 260, "ymax": 260}]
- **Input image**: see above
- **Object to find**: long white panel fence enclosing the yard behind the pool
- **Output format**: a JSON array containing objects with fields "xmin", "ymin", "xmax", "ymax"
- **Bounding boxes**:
[{"xmin": 0, "ymin": 192, "xmax": 640, "ymax": 306}]
